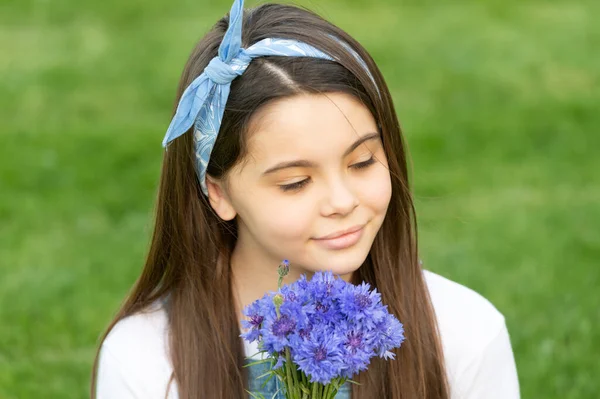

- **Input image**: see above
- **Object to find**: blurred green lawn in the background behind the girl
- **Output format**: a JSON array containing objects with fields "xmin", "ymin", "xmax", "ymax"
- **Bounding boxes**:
[{"xmin": 0, "ymin": 0, "xmax": 600, "ymax": 399}]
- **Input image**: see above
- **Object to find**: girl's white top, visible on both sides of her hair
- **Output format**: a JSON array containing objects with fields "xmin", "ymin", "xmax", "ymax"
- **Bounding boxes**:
[{"xmin": 96, "ymin": 271, "xmax": 519, "ymax": 399}]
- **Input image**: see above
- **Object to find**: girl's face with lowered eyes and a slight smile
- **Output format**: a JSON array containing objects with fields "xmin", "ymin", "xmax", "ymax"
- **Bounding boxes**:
[{"xmin": 208, "ymin": 93, "xmax": 391, "ymax": 280}]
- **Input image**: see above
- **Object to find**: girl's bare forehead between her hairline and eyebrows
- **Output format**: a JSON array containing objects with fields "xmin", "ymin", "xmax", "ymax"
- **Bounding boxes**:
[{"xmin": 248, "ymin": 93, "xmax": 377, "ymax": 162}]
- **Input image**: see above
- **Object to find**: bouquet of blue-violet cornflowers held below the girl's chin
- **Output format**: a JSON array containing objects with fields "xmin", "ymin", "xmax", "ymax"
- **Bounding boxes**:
[{"xmin": 241, "ymin": 261, "xmax": 404, "ymax": 399}]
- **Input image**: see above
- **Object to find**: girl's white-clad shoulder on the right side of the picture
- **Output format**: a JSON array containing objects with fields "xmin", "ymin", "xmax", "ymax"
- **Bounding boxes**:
[{"xmin": 423, "ymin": 270, "xmax": 519, "ymax": 399}]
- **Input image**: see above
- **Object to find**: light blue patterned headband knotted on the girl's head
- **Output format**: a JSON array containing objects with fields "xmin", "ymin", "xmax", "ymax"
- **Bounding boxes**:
[{"xmin": 162, "ymin": 0, "xmax": 373, "ymax": 196}]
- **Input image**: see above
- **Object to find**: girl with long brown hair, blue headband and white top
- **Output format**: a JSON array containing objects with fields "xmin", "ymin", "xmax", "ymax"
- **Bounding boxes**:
[{"xmin": 92, "ymin": 0, "xmax": 519, "ymax": 399}]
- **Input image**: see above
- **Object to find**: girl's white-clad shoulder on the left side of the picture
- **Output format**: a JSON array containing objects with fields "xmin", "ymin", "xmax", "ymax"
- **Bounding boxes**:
[{"xmin": 96, "ymin": 305, "xmax": 176, "ymax": 399}]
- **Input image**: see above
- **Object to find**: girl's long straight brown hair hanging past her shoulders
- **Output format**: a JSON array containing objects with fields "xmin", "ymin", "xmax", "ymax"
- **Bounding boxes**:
[{"xmin": 91, "ymin": 4, "xmax": 449, "ymax": 399}]
